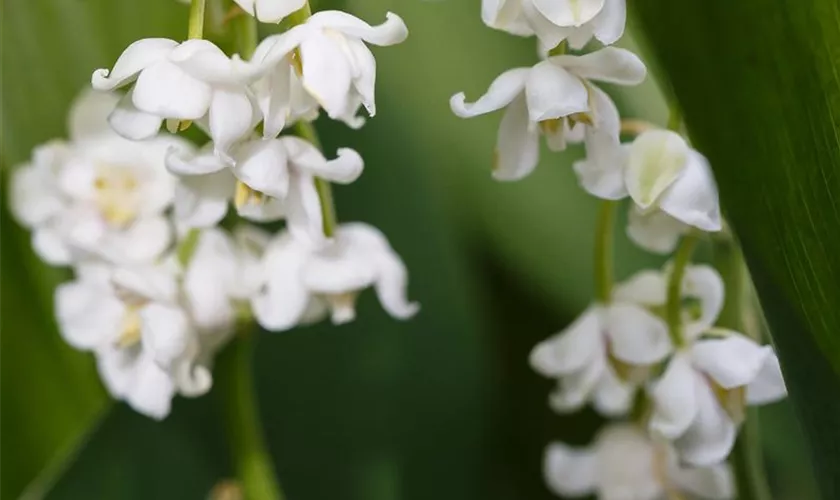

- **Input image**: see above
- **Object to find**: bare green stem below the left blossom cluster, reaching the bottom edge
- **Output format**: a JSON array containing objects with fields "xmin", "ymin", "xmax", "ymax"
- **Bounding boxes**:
[{"xmin": 217, "ymin": 325, "xmax": 284, "ymax": 500}]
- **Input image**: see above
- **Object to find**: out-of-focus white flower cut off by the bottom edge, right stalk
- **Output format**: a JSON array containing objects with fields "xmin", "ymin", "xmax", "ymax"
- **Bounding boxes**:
[{"xmin": 544, "ymin": 424, "xmax": 735, "ymax": 500}]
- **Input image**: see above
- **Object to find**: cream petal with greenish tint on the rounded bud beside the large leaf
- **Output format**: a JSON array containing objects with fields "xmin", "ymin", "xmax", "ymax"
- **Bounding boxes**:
[{"xmin": 625, "ymin": 130, "xmax": 691, "ymax": 210}]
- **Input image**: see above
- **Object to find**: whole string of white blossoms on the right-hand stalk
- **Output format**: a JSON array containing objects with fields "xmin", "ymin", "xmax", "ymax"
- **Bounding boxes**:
[{"xmin": 450, "ymin": 0, "xmax": 786, "ymax": 500}]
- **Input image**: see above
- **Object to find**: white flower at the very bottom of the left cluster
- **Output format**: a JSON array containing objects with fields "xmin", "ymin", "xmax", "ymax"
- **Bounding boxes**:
[{"xmin": 56, "ymin": 264, "xmax": 212, "ymax": 419}]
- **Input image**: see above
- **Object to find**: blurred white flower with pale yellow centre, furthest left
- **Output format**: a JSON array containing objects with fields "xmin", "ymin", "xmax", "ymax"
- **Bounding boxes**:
[{"xmin": 10, "ymin": 92, "xmax": 188, "ymax": 265}]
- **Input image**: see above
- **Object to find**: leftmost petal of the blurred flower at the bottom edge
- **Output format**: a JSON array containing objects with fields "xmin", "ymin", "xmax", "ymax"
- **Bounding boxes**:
[{"xmin": 543, "ymin": 443, "xmax": 598, "ymax": 497}]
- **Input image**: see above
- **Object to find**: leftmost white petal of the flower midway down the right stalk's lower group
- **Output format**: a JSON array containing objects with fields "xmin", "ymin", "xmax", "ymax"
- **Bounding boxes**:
[{"xmin": 528, "ymin": 307, "xmax": 603, "ymax": 377}]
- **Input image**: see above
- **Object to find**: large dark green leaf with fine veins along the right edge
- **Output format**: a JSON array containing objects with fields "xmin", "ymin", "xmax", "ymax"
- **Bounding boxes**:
[{"xmin": 633, "ymin": 0, "xmax": 840, "ymax": 498}]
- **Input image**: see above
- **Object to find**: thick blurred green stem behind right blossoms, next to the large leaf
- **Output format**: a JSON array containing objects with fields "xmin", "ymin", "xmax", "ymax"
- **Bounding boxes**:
[{"xmin": 713, "ymin": 238, "xmax": 772, "ymax": 500}]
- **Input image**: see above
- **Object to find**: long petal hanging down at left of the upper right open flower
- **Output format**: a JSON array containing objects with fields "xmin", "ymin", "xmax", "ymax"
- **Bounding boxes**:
[{"xmin": 493, "ymin": 95, "xmax": 540, "ymax": 181}]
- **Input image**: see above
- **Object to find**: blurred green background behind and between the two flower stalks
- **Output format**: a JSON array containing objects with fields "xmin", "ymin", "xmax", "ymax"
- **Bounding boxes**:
[{"xmin": 0, "ymin": 0, "xmax": 816, "ymax": 500}]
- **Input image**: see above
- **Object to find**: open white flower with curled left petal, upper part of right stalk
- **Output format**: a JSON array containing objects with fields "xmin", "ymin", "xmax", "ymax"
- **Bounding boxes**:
[{"xmin": 450, "ymin": 47, "xmax": 646, "ymax": 180}]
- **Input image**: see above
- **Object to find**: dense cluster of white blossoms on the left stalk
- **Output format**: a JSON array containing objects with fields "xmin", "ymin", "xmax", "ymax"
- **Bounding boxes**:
[{"xmin": 10, "ymin": 0, "xmax": 419, "ymax": 419}]
